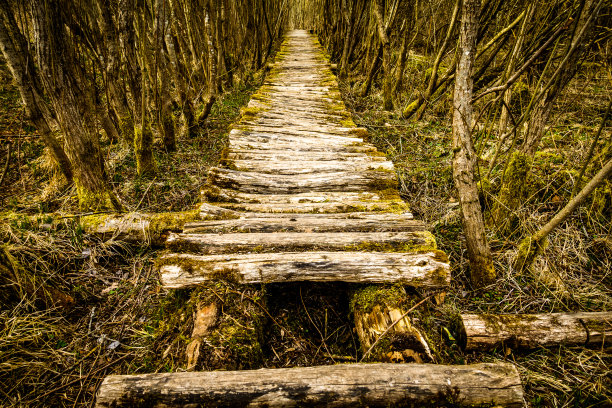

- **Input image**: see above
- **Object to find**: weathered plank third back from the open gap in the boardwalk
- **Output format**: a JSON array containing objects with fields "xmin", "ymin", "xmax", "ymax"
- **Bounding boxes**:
[{"xmin": 183, "ymin": 213, "xmax": 426, "ymax": 233}]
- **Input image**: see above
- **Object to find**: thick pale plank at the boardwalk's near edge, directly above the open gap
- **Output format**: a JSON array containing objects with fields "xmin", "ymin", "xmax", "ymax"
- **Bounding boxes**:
[{"xmin": 159, "ymin": 251, "xmax": 450, "ymax": 289}]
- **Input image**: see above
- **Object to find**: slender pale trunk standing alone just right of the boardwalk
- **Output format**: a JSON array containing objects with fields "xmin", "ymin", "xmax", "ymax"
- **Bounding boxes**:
[{"xmin": 453, "ymin": 0, "xmax": 495, "ymax": 287}]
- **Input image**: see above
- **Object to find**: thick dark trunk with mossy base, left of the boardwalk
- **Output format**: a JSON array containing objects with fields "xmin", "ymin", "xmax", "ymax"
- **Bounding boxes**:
[{"xmin": 31, "ymin": 0, "xmax": 120, "ymax": 210}]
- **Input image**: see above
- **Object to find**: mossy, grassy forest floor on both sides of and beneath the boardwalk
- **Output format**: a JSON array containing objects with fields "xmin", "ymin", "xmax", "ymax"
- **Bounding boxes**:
[{"xmin": 0, "ymin": 51, "xmax": 612, "ymax": 407}]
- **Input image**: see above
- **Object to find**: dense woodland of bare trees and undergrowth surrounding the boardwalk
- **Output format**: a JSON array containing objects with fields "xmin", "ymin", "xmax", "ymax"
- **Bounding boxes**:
[{"xmin": 0, "ymin": 0, "xmax": 612, "ymax": 407}]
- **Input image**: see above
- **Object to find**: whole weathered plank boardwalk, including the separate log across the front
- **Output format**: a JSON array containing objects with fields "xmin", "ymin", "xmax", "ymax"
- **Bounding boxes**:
[{"xmin": 97, "ymin": 31, "xmax": 523, "ymax": 407}]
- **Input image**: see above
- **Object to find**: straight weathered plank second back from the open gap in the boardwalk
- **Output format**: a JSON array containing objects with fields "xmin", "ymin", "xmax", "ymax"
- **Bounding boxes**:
[{"xmin": 166, "ymin": 231, "xmax": 436, "ymax": 254}]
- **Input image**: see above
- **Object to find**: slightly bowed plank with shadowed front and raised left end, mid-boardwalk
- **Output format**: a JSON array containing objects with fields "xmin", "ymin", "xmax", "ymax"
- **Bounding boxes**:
[{"xmin": 208, "ymin": 167, "xmax": 397, "ymax": 194}]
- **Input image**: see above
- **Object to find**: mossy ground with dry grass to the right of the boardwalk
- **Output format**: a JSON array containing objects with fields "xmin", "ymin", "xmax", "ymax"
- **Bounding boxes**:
[{"xmin": 341, "ymin": 60, "xmax": 612, "ymax": 407}]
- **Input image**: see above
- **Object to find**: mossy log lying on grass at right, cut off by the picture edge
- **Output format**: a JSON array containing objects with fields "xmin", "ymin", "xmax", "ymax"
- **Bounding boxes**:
[{"xmin": 461, "ymin": 312, "xmax": 612, "ymax": 350}]
